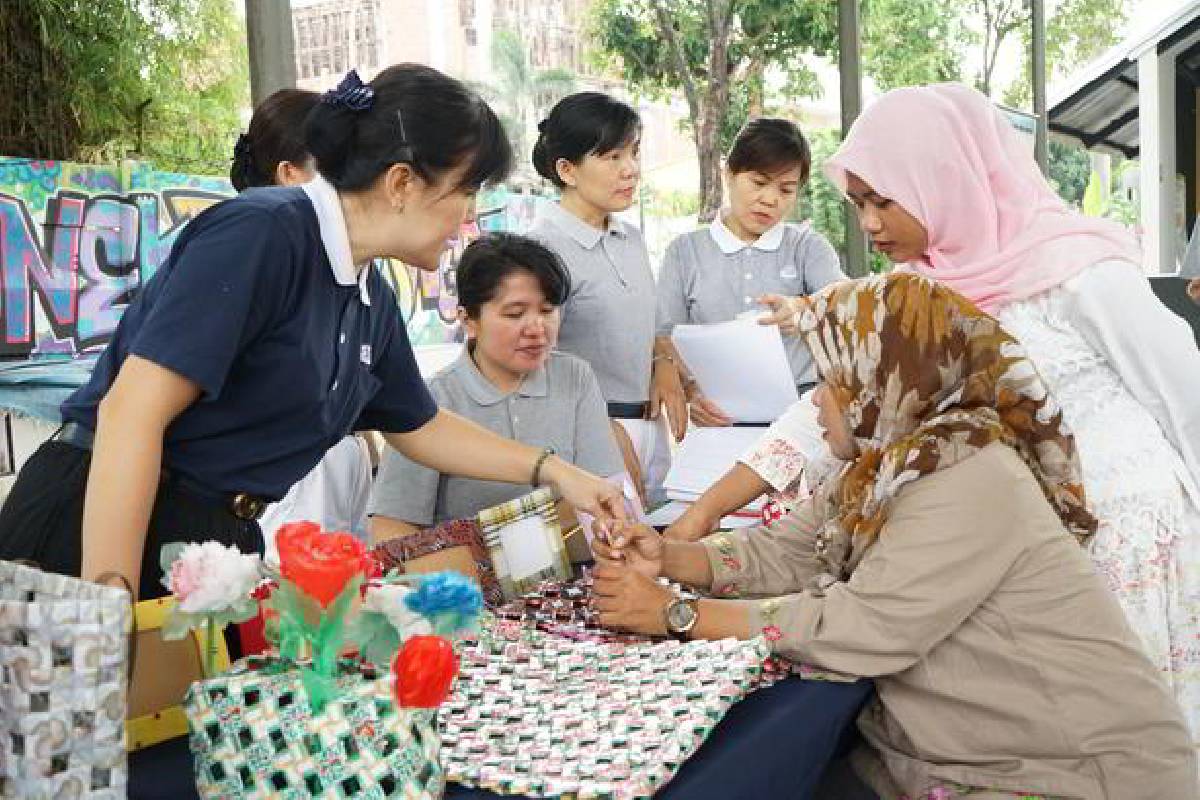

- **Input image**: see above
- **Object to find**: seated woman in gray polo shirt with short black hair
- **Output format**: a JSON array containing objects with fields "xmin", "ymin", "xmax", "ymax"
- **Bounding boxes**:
[{"xmin": 371, "ymin": 234, "xmax": 624, "ymax": 542}]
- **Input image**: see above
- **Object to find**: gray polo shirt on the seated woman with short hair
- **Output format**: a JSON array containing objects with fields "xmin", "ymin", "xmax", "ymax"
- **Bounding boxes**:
[{"xmin": 370, "ymin": 348, "xmax": 625, "ymax": 525}]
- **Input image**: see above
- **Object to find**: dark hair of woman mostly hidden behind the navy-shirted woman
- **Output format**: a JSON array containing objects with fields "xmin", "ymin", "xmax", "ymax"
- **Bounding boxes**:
[{"xmin": 229, "ymin": 89, "xmax": 320, "ymax": 192}]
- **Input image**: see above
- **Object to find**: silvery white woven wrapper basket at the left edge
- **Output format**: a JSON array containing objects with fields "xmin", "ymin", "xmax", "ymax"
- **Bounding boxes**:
[{"xmin": 0, "ymin": 561, "xmax": 133, "ymax": 800}]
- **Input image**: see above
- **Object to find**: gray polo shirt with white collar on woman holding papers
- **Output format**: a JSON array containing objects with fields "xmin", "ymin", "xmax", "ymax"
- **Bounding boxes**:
[{"xmin": 658, "ymin": 215, "xmax": 846, "ymax": 384}]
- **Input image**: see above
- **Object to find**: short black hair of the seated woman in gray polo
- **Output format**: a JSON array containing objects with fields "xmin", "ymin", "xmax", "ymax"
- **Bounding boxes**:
[{"xmin": 455, "ymin": 233, "xmax": 571, "ymax": 319}]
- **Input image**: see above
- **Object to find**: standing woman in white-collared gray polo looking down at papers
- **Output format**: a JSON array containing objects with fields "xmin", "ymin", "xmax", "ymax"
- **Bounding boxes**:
[{"xmin": 658, "ymin": 118, "xmax": 846, "ymax": 426}]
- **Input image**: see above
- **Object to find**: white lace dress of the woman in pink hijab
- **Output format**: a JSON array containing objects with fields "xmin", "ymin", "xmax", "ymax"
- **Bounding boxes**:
[{"xmin": 997, "ymin": 261, "xmax": 1200, "ymax": 741}]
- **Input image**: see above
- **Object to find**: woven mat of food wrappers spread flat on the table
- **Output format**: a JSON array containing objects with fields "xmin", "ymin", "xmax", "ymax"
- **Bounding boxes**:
[{"xmin": 439, "ymin": 577, "xmax": 848, "ymax": 800}]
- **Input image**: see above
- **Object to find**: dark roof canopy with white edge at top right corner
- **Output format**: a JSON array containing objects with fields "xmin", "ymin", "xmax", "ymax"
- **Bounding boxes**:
[{"xmin": 1050, "ymin": 0, "xmax": 1200, "ymax": 158}]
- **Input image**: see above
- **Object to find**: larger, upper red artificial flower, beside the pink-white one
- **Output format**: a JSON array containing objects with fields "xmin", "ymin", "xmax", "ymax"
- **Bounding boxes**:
[{"xmin": 275, "ymin": 522, "xmax": 370, "ymax": 608}]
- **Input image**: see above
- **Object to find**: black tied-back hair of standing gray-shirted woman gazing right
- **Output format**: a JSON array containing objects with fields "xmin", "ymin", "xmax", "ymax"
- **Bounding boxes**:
[{"xmin": 533, "ymin": 91, "xmax": 642, "ymax": 188}]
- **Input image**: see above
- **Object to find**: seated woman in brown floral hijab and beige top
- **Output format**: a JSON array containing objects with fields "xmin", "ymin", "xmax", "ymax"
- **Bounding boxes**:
[{"xmin": 595, "ymin": 273, "xmax": 1200, "ymax": 800}]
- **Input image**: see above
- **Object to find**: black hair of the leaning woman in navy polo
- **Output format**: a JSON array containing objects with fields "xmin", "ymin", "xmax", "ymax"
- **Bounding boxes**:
[{"xmin": 305, "ymin": 64, "xmax": 512, "ymax": 192}]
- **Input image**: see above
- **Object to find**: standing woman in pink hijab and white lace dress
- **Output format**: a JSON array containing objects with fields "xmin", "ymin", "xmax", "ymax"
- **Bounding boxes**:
[{"xmin": 806, "ymin": 84, "xmax": 1200, "ymax": 740}]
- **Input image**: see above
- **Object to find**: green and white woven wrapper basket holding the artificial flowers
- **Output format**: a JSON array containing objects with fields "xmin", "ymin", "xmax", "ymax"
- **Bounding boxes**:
[{"xmin": 184, "ymin": 656, "xmax": 444, "ymax": 800}]
